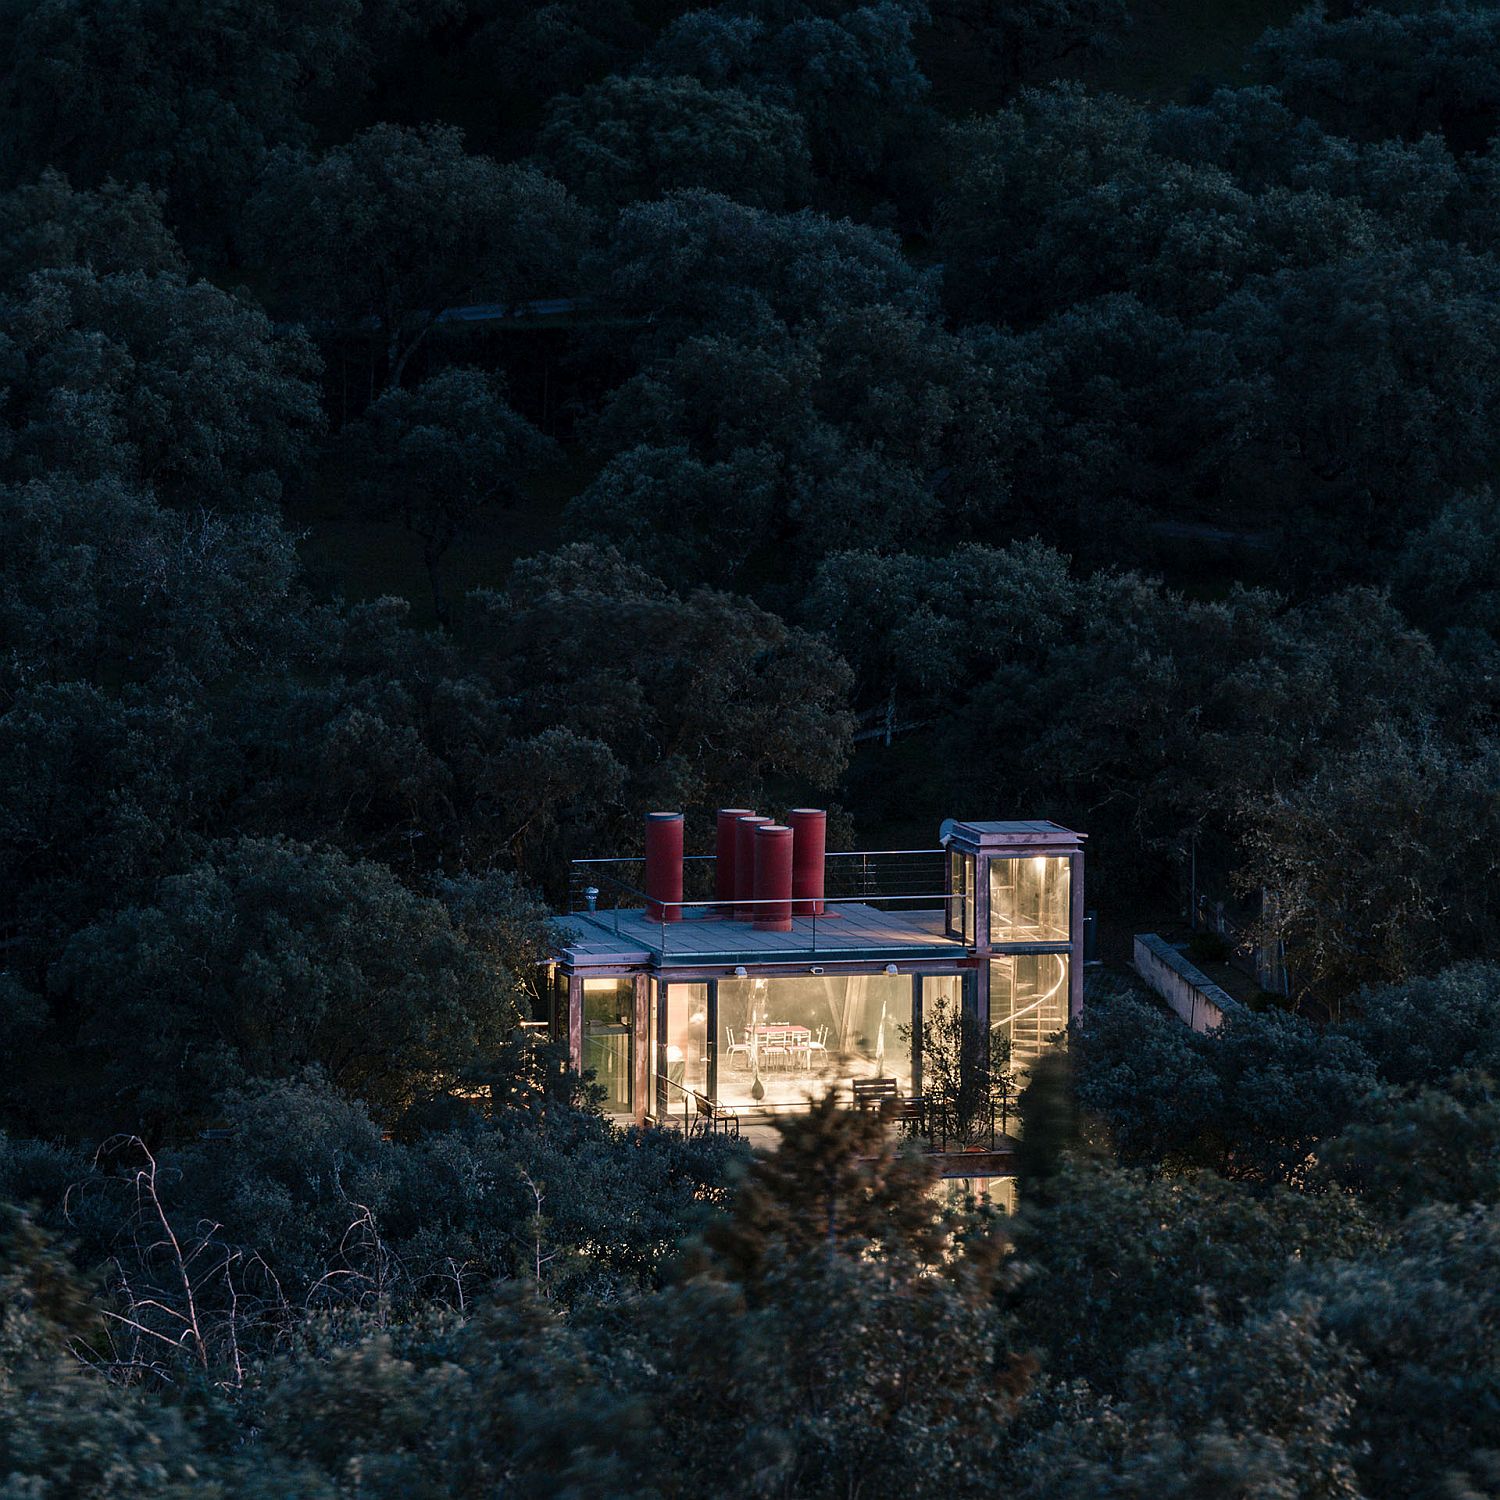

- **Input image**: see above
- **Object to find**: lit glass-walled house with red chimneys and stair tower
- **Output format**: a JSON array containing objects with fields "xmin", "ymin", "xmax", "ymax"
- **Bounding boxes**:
[{"xmin": 549, "ymin": 809, "xmax": 1085, "ymax": 1122}]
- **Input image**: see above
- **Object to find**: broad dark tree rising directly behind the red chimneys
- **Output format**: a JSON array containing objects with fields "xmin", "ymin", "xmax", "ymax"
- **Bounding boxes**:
[{"xmin": 464, "ymin": 543, "xmax": 852, "ymax": 849}]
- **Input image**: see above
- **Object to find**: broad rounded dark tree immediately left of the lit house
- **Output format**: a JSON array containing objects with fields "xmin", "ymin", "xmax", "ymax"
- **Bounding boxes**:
[{"xmin": 53, "ymin": 840, "xmax": 516, "ymax": 1131}]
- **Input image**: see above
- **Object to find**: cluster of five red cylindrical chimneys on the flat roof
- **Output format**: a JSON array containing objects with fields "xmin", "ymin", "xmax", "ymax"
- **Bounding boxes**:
[{"xmin": 647, "ymin": 807, "xmax": 828, "ymax": 933}]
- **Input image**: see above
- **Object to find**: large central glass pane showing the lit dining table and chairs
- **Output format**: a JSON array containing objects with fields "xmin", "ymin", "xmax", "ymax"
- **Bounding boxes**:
[{"xmin": 717, "ymin": 974, "xmax": 912, "ymax": 1109}]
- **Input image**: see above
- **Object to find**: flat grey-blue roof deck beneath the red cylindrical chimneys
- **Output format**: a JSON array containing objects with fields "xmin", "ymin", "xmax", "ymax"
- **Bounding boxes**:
[{"xmin": 557, "ymin": 902, "xmax": 971, "ymax": 969}]
